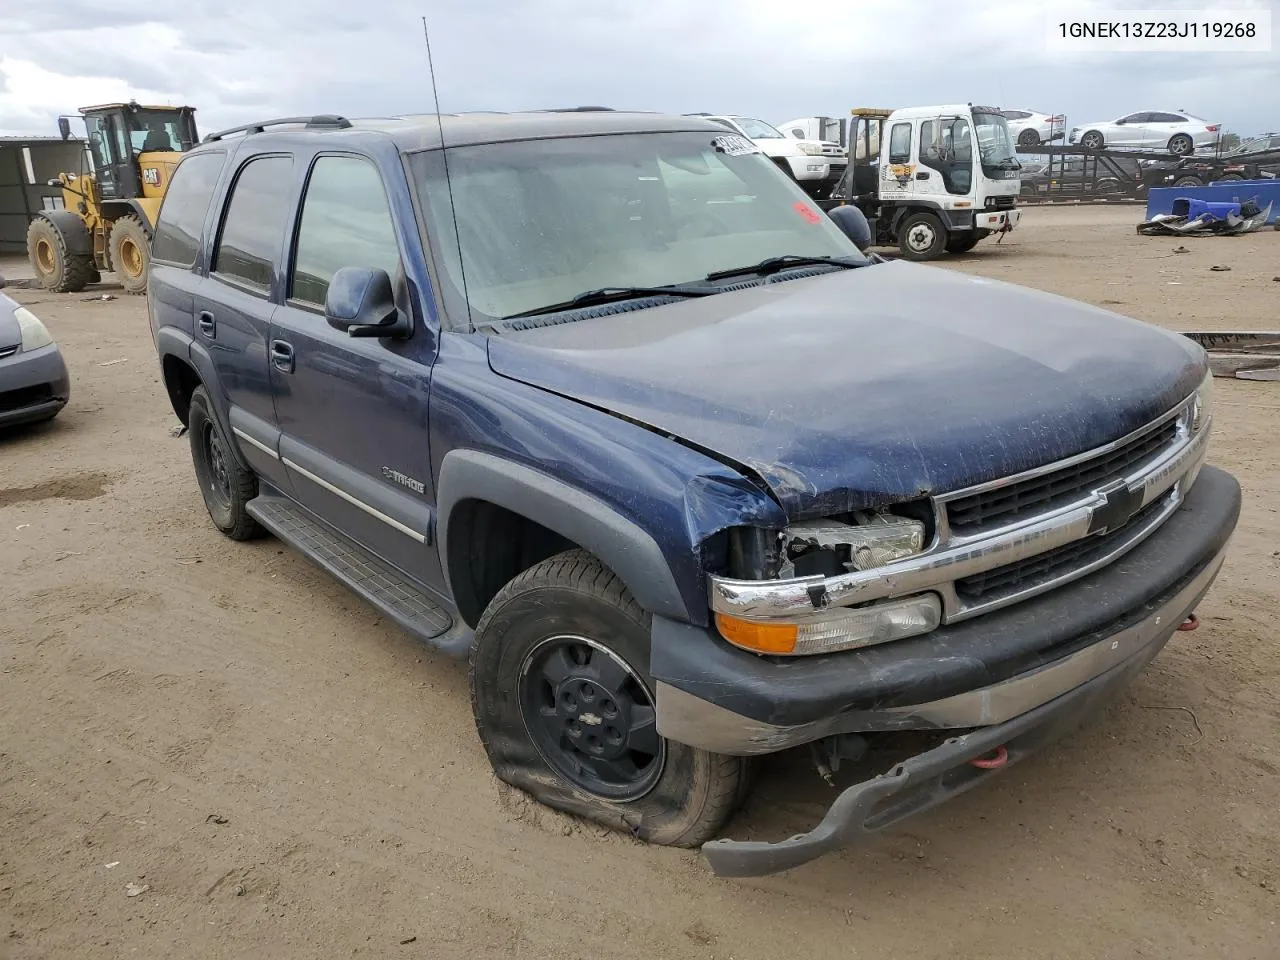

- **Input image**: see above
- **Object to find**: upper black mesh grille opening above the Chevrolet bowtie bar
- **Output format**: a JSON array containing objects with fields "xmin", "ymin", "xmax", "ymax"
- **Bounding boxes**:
[{"xmin": 947, "ymin": 420, "xmax": 1178, "ymax": 534}]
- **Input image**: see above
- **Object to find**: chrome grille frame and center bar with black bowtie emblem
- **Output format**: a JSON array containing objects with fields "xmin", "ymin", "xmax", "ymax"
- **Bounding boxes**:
[{"xmin": 708, "ymin": 394, "xmax": 1212, "ymax": 623}]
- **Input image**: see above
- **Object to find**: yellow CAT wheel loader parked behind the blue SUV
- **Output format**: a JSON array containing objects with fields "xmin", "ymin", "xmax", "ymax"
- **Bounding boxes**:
[{"xmin": 27, "ymin": 101, "xmax": 197, "ymax": 293}]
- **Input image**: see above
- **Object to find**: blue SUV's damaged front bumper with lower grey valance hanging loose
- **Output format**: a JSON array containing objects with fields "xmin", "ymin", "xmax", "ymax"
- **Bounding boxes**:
[{"xmin": 652, "ymin": 467, "xmax": 1240, "ymax": 877}]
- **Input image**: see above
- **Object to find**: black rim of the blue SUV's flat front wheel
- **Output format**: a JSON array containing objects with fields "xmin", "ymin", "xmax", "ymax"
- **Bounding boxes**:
[{"xmin": 520, "ymin": 635, "xmax": 667, "ymax": 800}]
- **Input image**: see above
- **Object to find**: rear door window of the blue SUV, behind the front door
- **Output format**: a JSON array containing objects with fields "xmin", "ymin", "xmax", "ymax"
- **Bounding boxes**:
[{"xmin": 212, "ymin": 156, "xmax": 293, "ymax": 293}]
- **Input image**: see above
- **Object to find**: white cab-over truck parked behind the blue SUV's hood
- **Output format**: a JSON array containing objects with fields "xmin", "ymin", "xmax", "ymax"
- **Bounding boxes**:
[{"xmin": 803, "ymin": 104, "xmax": 1021, "ymax": 260}]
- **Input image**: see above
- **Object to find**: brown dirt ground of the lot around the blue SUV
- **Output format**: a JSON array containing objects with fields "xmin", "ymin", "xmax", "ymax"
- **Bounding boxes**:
[{"xmin": 0, "ymin": 207, "xmax": 1280, "ymax": 960}]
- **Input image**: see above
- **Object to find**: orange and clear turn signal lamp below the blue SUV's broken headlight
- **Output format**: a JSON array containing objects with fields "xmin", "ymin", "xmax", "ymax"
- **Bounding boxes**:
[{"xmin": 716, "ymin": 594, "xmax": 942, "ymax": 657}]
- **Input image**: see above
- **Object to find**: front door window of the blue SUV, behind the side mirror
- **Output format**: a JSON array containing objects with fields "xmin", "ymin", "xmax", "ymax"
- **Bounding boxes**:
[{"xmin": 289, "ymin": 156, "xmax": 399, "ymax": 306}]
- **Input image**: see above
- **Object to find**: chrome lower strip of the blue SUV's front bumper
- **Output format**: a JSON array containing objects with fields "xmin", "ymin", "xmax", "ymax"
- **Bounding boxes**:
[{"xmin": 657, "ymin": 545, "xmax": 1226, "ymax": 756}]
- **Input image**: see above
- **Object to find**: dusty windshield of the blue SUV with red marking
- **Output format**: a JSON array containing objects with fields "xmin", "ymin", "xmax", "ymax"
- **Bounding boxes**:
[{"xmin": 410, "ymin": 132, "xmax": 865, "ymax": 323}]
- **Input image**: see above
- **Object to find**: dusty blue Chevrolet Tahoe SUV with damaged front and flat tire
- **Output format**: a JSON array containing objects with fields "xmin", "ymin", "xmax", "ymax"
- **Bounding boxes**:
[{"xmin": 148, "ymin": 109, "xmax": 1240, "ymax": 876}]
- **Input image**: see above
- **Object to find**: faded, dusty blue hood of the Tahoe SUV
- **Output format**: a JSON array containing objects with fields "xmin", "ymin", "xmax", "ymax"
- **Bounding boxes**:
[{"xmin": 489, "ymin": 261, "xmax": 1208, "ymax": 518}]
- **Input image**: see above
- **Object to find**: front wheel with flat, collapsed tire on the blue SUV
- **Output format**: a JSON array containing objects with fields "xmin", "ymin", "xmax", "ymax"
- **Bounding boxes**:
[{"xmin": 468, "ymin": 550, "xmax": 748, "ymax": 846}]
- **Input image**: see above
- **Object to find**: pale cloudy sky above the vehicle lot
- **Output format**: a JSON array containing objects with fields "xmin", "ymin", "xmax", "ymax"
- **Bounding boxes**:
[{"xmin": 0, "ymin": 0, "xmax": 1280, "ymax": 134}]
